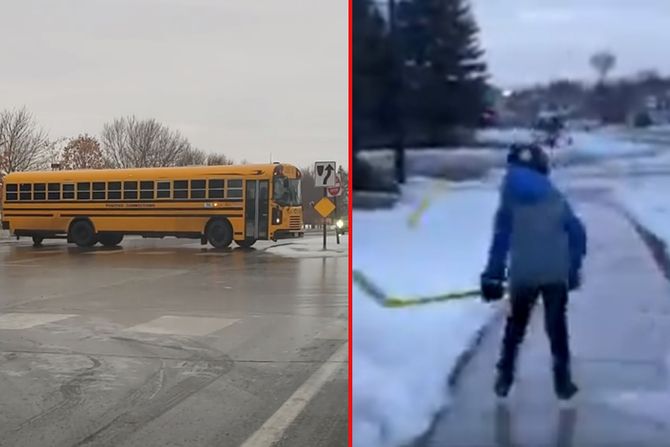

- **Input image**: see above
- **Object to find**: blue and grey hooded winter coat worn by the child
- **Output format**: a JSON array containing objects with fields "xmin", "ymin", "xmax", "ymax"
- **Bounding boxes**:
[{"xmin": 485, "ymin": 166, "xmax": 587, "ymax": 287}]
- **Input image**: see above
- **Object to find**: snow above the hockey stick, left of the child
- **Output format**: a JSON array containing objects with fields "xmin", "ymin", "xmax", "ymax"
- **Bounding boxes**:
[{"xmin": 360, "ymin": 180, "xmax": 498, "ymax": 296}]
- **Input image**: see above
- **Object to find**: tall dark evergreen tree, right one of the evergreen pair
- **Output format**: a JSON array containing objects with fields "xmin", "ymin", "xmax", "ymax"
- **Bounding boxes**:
[{"xmin": 398, "ymin": 0, "xmax": 487, "ymax": 143}]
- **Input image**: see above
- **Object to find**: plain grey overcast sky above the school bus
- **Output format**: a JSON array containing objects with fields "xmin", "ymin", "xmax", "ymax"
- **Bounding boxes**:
[{"xmin": 0, "ymin": 0, "xmax": 348, "ymax": 171}]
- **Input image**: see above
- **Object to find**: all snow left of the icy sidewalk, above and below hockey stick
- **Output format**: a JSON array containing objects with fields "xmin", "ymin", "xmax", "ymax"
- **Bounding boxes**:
[{"xmin": 352, "ymin": 179, "xmax": 497, "ymax": 447}]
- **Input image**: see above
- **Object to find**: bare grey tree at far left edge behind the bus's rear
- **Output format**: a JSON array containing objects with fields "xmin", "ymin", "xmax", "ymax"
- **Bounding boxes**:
[{"xmin": 0, "ymin": 108, "xmax": 49, "ymax": 172}]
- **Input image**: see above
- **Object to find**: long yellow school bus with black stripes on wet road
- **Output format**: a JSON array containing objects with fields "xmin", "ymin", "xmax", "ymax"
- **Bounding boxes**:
[{"xmin": 2, "ymin": 163, "xmax": 304, "ymax": 248}]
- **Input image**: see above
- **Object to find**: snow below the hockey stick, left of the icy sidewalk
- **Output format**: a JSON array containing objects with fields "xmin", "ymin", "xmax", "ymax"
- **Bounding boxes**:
[{"xmin": 352, "ymin": 286, "xmax": 494, "ymax": 447}]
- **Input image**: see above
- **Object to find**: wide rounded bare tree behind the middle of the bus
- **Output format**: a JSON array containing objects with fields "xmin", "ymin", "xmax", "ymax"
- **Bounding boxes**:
[{"xmin": 101, "ymin": 116, "xmax": 192, "ymax": 168}]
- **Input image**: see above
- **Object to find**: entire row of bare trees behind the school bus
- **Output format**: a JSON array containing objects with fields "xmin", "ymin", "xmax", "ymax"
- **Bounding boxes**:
[{"xmin": 0, "ymin": 108, "xmax": 246, "ymax": 173}]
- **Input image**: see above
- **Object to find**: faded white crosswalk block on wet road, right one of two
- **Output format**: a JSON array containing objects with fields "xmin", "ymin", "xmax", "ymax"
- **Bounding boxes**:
[{"xmin": 125, "ymin": 315, "xmax": 239, "ymax": 335}]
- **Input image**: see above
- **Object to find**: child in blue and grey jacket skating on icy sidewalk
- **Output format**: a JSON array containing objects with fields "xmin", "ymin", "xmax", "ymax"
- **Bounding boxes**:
[{"xmin": 482, "ymin": 145, "xmax": 586, "ymax": 399}]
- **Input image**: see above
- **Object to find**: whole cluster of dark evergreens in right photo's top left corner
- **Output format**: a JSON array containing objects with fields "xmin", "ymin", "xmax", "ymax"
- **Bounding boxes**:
[{"xmin": 352, "ymin": 0, "xmax": 489, "ymax": 148}]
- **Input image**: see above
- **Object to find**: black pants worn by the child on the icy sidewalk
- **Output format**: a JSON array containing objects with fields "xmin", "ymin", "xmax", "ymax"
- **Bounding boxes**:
[{"xmin": 498, "ymin": 284, "xmax": 571, "ymax": 387}]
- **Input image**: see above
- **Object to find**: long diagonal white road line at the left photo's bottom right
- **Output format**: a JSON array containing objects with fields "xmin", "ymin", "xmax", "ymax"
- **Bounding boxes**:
[{"xmin": 240, "ymin": 343, "xmax": 348, "ymax": 447}]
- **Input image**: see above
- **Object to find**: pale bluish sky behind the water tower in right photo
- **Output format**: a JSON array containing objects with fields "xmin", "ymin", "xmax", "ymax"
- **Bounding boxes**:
[{"xmin": 472, "ymin": 0, "xmax": 670, "ymax": 86}]
